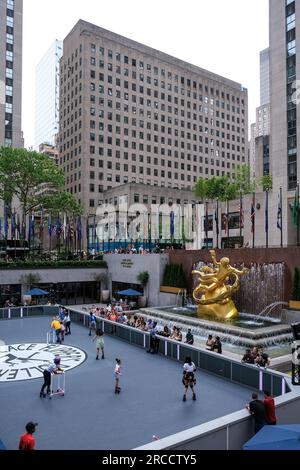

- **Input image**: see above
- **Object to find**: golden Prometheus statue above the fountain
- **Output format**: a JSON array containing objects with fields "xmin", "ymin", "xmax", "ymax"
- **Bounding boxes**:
[{"xmin": 192, "ymin": 250, "xmax": 249, "ymax": 320}]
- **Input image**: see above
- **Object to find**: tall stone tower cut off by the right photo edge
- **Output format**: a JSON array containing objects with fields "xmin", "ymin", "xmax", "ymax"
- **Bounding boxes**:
[{"xmin": 270, "ymin": 0, "xmax": 300, "ymax": 244}]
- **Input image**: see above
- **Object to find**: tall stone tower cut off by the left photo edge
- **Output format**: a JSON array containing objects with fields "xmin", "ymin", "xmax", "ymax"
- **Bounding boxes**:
[{"xmin": 0, "ymin": 0, "xmax": 24, "ymax": 147}]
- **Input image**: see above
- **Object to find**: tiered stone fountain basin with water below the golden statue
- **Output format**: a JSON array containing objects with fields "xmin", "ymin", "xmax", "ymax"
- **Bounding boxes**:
[{"xmin": 141, "ymin": 307, "xmax": 293, "ymax": 348}]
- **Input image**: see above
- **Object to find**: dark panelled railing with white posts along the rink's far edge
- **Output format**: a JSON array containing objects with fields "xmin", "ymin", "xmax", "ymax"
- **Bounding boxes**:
[{"xmin": 0, "ymin": 305, "xmax": 290, "ymax": 396}]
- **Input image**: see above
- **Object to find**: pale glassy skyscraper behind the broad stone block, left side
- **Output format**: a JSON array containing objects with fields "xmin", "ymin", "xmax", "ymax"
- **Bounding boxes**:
[{"xmin": 35, "ymin": 39, "xmax": 63, "ymax": 149}]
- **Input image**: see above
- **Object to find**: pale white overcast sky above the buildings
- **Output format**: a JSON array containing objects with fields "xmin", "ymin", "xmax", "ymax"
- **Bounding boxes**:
[{"xmin": 22, "ymin": 0, "xmax": 269, "ymax": 147}]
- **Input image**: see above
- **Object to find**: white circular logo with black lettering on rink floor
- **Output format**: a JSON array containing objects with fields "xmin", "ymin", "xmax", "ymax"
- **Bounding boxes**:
[{"xmin": 0, "ymin": 343, "xmax": 86, "ymax": 382}]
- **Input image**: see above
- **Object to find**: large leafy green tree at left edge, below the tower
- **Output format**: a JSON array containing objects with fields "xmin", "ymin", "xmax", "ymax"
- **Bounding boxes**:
[{"xmin": 0, "ymin": 147, "xmax": 82, "ymax": 220}]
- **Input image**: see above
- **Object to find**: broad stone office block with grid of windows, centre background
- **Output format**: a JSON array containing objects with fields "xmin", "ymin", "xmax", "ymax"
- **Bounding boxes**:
[{"xmin": 59, "ymin": 20, "xmax": 248, "ymax": 212}]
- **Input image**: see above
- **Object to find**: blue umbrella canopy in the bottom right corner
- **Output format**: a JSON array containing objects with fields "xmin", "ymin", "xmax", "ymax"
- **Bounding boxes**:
[{"xmin": 243, "ymin": 424, "xmax": 300, "ymax": 450}]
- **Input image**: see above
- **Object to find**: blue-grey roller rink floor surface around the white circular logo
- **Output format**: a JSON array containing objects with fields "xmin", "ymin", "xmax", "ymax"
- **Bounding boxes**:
[{"xmin": 0, "ymin": 318, "xmax": 251, "ymax": 450}]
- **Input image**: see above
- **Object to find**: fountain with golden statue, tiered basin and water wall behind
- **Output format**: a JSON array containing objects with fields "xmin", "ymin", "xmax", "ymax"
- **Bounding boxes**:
[{"xmin": 143, "ymin": 251, "xmax": 292, "ymax": 347}]
